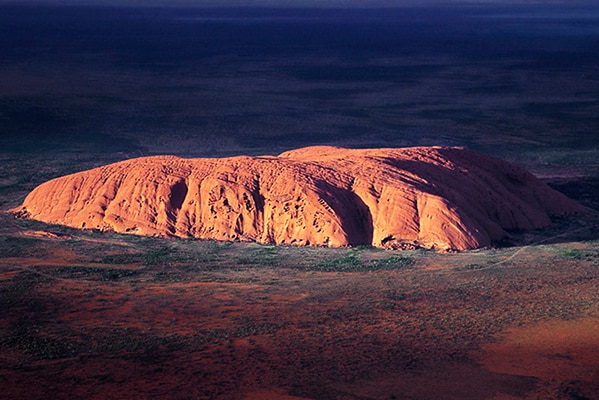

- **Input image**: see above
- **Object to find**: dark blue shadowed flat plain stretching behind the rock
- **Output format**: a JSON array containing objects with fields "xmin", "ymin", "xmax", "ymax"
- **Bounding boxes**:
[{"xmin": 0, "ymin": 4, "xmax": 599, "ymax": 169}]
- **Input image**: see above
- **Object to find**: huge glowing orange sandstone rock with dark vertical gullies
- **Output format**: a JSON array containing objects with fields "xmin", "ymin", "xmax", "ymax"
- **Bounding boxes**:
[{"xmin": 12, "ymin": 146, "xmax": 584, "ymax": 250}]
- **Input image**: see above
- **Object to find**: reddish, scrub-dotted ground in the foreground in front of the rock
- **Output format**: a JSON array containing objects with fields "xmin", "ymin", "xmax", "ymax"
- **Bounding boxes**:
[{"xmin": 0, "ymin": 211, "xmax": 599, "ymax": 400}]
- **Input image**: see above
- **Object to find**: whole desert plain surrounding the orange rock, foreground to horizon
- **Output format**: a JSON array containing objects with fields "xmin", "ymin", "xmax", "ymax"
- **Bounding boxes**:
[{"xmin": 0, "ymin": 5, "xmax": 599, "ymax": 400}]
